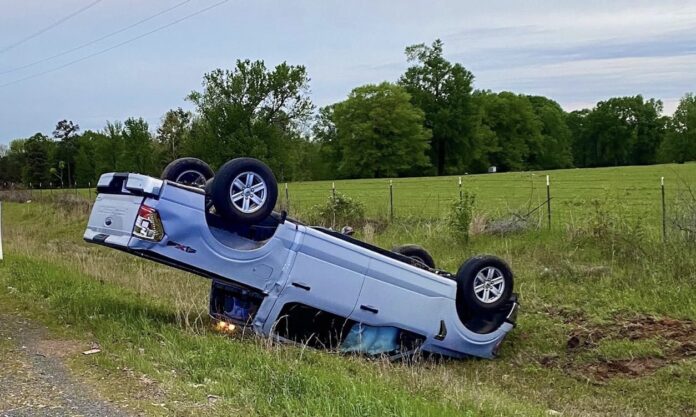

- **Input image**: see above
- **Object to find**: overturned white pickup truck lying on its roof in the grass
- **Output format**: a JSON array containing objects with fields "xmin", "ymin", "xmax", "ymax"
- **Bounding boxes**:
[{"xmin": 84, "ymin": 158, "xmax": 518, "ymax": 358}]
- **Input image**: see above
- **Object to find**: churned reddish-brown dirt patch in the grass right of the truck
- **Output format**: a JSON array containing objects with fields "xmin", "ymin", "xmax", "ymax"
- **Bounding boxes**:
[{"xmin": 539, "ymin": 307, "xmax": 696, "ymax": 383}]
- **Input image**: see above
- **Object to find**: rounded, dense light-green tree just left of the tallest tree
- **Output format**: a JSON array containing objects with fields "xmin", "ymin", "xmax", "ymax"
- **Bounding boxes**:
[{"xmin": 326, "ymin": 82, "xmax": 430, "ymax": 178}]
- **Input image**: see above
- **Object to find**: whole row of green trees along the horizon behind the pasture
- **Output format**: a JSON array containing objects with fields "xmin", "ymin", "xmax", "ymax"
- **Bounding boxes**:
[{"xmin": 0, "ymin": 40, "xmax": 696, "ymax": 186}]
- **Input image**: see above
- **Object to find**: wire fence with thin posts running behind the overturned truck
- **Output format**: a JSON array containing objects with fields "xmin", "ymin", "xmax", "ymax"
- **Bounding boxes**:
[{"xmin": 0, "ymin": 173, "xmax": 684, "ymax": 236}]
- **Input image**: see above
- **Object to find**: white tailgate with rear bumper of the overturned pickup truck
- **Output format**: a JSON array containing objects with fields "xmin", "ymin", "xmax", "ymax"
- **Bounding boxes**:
[{"xmin": 84, "ymin": 173, "xmax": 162, "ymax": 247}]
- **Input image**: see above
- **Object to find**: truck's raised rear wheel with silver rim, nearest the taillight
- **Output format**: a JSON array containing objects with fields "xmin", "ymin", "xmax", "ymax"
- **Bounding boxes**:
[{"xmin": 209, "ymin": 158, "xmax": 278, "ymax": 225}]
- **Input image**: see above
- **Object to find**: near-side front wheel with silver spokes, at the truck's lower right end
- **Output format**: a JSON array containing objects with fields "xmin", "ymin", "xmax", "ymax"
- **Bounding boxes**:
[{"xmin": 456, "ymin": 255, "xmax": 513, "ymax": 317}]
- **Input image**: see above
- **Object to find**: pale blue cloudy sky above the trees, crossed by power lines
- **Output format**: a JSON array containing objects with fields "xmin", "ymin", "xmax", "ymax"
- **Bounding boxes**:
[{"xmin": 0, "ymin": 0, "xmax": 696, "ymax": 143}]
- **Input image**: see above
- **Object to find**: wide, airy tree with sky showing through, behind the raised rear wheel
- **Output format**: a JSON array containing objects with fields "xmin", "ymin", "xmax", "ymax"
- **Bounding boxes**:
[{"xmin": 185, "ymin": 60, "xmax": 313, "ymax": 178}]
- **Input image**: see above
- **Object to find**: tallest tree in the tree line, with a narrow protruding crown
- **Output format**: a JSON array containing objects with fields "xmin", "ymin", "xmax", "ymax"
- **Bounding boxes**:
[{"xmin": 399, "ymin": 39, "xmax": 479, "ymax": 175}]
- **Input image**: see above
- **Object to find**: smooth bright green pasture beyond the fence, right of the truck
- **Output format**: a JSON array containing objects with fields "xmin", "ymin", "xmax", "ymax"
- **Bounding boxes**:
[{"xmin": 280, "ymin": 163, "xmax": 696, "ymax": 232}]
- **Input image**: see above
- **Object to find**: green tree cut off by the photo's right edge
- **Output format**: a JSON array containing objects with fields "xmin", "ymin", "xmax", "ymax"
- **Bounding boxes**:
[{"xmin": 659, "ymin": 93, "xmax": 696, "ymax": 163}]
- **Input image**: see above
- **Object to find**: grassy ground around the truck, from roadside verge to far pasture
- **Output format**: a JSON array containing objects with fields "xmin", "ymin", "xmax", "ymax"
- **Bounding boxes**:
[{"xmin": 0, "ymin": 164, "xmax": 696, "ymax": 416}]
